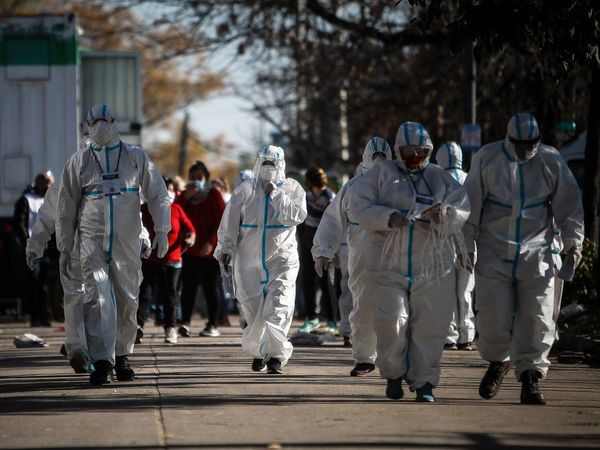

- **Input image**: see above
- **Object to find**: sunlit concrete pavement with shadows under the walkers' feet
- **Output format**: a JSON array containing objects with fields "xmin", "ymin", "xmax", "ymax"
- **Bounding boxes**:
[{"xmin": 0, "ymin": 321, "xmax": 600, "ymax": 449}]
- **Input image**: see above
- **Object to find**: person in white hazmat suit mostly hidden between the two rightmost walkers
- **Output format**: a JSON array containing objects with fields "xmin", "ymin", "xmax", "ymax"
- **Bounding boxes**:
[{"xmin": 435, "ymin": 141, "xmax": 475, "ymax": 350}]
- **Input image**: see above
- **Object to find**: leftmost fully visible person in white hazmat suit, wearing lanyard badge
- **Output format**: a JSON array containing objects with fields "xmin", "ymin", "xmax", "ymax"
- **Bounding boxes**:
[{"xmin": 56, "ymin": 105, "xmax": 171, "ymax": 384}]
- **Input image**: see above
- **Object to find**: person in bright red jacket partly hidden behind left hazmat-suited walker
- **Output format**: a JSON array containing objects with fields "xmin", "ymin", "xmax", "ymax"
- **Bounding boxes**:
[{"xmin": 138, "ymin": 177, "xmax": 196, "ymax": 344}]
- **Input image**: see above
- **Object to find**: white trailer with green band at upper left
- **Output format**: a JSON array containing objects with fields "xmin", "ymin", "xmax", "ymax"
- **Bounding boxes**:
[{"xmin": 0, "ymin": 15, "xmax": 80, "ymax": 217}]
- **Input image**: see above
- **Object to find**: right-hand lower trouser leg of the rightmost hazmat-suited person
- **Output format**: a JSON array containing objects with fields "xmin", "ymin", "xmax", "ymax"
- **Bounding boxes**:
[{"xmin": 510, "ymin": 270, "xmax": 555, "ymax": 380}]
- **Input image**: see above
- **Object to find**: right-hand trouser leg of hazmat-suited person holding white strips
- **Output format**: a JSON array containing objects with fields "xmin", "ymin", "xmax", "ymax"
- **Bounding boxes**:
[{"xmin": 406, "ymin": 270, "xmax": 456, "ymax": 390}]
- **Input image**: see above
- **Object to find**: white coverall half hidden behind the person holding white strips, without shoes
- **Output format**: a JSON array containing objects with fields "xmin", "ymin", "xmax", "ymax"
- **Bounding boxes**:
[{"xmin": 312, "ymin": 137, "xmax": 392, "ymax": 348}]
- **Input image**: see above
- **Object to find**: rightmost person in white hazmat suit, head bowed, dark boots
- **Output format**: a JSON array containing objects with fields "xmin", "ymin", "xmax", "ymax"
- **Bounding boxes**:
[{"xmin": 464, "ymin": 113, "xmax": 583, "ymax": 405}]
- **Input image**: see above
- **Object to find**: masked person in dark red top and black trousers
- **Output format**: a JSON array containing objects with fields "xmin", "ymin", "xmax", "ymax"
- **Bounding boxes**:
[{"xmin": 175, "ymin": 161, "xmax": 225, "ymax": 337}]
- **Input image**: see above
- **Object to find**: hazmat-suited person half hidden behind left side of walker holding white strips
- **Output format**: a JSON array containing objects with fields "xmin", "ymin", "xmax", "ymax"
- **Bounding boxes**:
[{"xmin": 312, "ymin": 137, "xmax": 392, "ymax": 376}]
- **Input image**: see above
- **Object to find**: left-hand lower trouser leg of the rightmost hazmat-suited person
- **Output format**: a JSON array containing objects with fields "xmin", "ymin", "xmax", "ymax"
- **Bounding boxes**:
[{"xmin": 475, "ymin": 273, "xmax": 514, "ymax": 361}]
